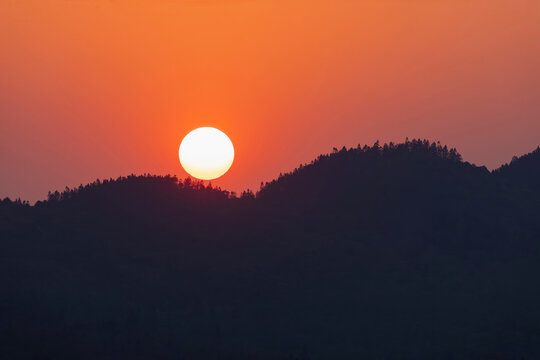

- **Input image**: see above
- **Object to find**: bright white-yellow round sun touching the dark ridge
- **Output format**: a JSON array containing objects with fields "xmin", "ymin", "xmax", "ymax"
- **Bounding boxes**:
[{"xmin": 178, "ymin": 127, "xmax": 234, "ymax": 180}]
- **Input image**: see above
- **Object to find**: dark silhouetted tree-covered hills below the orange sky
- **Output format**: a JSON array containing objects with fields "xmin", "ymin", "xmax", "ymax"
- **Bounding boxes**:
[{"xmin": 0, "ymin": 141, "xmax": 540, "ymax": 359}]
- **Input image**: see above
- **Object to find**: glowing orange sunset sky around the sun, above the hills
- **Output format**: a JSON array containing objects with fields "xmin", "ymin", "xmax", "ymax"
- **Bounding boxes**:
[{"xmin": 0, "ymin": 0, "xmax": 540, "ymax": 201}]
